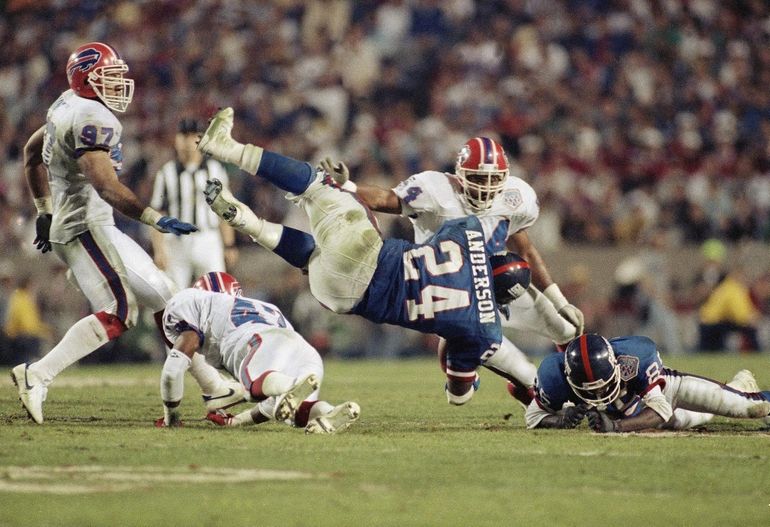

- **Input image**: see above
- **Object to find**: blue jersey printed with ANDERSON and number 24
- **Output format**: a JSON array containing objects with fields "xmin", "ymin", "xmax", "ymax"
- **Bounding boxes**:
[{"xmin": 352, "ymin": 216, "xmax": 502, "ymax": 370}]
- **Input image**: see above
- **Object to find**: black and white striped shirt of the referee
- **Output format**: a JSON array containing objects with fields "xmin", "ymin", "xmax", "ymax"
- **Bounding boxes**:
[{"xmin": 150, "ymin": 159, "xmax": 228, "ymax": 231}]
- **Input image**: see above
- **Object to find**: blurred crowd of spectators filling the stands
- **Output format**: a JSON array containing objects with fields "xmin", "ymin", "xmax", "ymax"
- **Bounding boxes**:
[{"xmin": 0, "ymin": 0, "xmax": 770, "ymax": 360}]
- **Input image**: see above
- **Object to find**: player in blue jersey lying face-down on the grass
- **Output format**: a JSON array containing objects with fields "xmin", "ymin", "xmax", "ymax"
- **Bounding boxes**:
[{"xmin": 525, "ymin": 334, "xmax": 770, "ymax": 432}]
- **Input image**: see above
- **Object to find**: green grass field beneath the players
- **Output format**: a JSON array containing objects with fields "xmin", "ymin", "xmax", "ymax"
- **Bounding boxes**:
[{"xmin": 0, "ymin": 355, "xmax": 770, "ymax": 527}]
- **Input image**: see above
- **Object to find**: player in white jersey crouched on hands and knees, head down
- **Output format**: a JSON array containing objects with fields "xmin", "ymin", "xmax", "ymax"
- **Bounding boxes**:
[{"xmin": 156, "ymin": 272, "xmax": 361, "ymax": 434}]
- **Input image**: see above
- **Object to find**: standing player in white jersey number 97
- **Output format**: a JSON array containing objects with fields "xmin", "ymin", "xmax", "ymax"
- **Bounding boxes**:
[{"xmin": 11, "ymin": 42, "xmax": 242, "ymax": 424}]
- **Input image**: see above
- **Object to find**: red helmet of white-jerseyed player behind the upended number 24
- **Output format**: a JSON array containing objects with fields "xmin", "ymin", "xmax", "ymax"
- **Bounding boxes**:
[{"xmin": 455, "ymin": 137, "xmax": 508, "ymax": 211}]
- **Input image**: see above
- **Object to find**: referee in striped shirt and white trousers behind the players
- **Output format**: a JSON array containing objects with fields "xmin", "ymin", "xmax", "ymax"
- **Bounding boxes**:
[{"xmin": 151, "ymin": 119, "xmax": 238, "ymax": 288}]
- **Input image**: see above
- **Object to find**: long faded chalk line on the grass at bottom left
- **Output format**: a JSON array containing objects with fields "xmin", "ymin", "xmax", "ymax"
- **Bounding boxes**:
[{"xmin": 0, "ymin": 465, "xmax": 329, "ymax": 494}]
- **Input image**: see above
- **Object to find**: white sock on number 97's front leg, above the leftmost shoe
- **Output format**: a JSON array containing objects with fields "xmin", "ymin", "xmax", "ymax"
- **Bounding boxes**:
[{"xmin": 28, "ymin": 315, "xmax": 110, "ymax": 386}]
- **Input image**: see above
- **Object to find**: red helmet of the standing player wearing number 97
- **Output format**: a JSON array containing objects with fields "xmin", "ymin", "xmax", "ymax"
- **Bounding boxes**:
[{"xmin": 67, "ymin": 42, "xmax": 134, "ymax": 112}]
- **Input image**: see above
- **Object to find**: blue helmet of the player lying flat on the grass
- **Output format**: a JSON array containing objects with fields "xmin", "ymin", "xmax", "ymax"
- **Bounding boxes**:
[{"xmin": 564, "ymin": 334, "xmax": 620, "ymax": 407}]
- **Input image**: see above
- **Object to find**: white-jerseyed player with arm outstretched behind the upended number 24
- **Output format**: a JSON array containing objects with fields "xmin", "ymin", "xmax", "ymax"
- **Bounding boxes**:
[{"xmin": 326, "ymin": 137, "xmax": 583, "ymax": 406}]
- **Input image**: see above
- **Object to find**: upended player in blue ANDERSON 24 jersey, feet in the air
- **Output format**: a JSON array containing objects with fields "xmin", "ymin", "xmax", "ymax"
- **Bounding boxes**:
[{"xmin": 199, "ymin": 108, "xmax": 530, "ymax": 405}]
